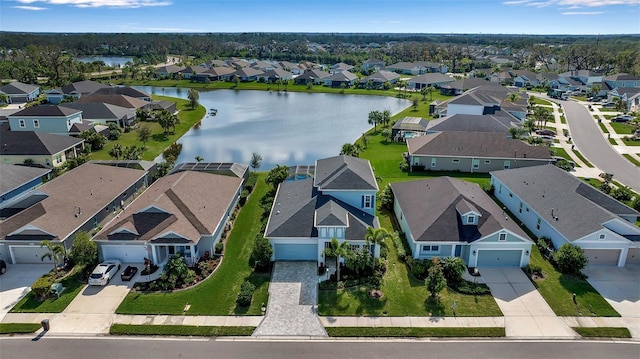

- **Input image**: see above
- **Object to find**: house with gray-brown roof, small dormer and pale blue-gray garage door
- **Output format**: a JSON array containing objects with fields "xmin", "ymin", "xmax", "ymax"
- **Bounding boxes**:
[{"xmin": 391, "ymin": 176, "xmax": 533, "ymax": 267}]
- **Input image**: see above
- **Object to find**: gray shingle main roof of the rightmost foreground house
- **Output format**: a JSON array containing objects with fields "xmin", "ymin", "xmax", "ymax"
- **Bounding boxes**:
[{"xmin": 491, "ymin": 165, "xmax": 640, "ymax": 241}]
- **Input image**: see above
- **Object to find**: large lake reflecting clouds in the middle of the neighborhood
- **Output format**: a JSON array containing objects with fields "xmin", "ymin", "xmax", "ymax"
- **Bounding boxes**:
[{"xmin": 135, "ymin": 86, "xmax": 411, "ymax": 170}]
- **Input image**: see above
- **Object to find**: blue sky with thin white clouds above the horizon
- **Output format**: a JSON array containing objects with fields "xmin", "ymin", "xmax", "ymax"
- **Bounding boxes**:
[{"xmin": 0, "ymin": 0, "xmax": 640, "ymax": 34}]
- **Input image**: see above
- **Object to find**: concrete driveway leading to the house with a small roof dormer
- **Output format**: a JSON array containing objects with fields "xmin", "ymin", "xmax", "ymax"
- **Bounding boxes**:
[{"xmin": 479, "ymin": 267, "xmax": 577, "ymax": 337}]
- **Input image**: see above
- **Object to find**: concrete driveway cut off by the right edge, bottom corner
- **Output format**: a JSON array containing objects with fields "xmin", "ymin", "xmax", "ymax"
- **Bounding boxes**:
[{"xmin": 584, "ymin": 265, "xmax": 640, "ymax": 338}]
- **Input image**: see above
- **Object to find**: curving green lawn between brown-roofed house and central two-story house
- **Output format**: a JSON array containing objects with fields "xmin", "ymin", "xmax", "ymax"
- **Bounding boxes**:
[{"xmin": 116, "ymin": 174, "xmax": 269, "ymax": 315}]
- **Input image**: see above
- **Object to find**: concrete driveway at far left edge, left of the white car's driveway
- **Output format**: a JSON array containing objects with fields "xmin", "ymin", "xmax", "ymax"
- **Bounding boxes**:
[{"xmin": 0, "ymin": 264, "xmax": 53, "ymax": 322}]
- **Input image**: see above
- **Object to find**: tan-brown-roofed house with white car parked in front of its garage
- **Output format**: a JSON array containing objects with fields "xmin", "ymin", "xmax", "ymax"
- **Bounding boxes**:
[{"xmin": 93, "ymin": 171, "xmax": 244, "ymax": 266}]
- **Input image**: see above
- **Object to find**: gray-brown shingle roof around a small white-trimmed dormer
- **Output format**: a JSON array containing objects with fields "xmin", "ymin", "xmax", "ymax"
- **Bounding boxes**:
[{"xmin": 391, "ymin": 177, "xmax": 528, "ymax": 243}]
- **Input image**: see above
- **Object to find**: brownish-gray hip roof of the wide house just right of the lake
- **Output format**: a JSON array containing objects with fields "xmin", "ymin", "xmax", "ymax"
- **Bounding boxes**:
[{"xmin": 407, "ymin": 131, "xmax": 551, "ymax": 160}]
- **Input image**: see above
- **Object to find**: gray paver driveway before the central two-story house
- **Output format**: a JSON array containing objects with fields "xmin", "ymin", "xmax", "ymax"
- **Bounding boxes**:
[{"xmin": 253, "ymin": 262, "xmax": 327, "ymax": 336}]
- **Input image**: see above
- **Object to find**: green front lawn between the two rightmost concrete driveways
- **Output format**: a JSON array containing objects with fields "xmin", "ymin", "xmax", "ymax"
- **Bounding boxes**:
[{"xmin": 530, "ymin": 246, "xmax": 620, "ymax": 317}]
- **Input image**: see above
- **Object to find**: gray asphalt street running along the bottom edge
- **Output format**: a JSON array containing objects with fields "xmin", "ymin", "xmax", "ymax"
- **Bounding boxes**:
[{"xmin": 0, "ymin": 338, "xmax": 640, "ymax": 359}]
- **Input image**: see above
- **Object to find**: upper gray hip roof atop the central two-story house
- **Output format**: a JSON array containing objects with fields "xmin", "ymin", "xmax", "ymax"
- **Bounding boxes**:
[{"xmin": 314, "ymin": 155, "xmax": 378, "ymax": 191}]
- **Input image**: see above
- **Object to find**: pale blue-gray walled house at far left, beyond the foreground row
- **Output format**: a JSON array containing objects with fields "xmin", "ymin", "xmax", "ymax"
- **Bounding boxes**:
[{"xmin": 8, "ymin": 105, "xmax": 82, "ymax": 135}]
